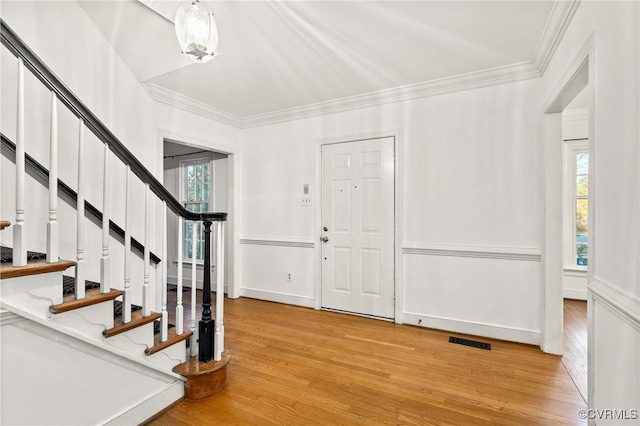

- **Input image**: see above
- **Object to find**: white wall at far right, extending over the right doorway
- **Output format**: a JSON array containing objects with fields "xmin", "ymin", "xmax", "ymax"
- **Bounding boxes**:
[{"xmin": 542, "ymin": 2, "xmax": 640, "ymax": 425}]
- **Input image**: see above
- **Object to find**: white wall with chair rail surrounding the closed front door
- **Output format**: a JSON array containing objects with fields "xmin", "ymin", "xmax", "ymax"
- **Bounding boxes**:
[{"xmin": 241, "ymin": 80, "xmax": 542, "ymax": 343}]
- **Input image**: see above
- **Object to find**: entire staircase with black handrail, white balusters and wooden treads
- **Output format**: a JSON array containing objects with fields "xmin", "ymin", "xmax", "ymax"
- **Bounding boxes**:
[{"xmin": 0, "ymin": 20, "xmax": 229, "ymax": 425}]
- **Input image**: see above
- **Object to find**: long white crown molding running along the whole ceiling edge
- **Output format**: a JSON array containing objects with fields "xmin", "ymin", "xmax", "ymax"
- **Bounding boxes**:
[{"xmin": 144, "ymin": 0, "xmax": 580, "ymax": 129}]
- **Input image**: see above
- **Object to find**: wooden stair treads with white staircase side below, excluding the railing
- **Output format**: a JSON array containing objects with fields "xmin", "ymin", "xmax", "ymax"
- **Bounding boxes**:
[{"xmin": 0, "ymin": 236, "xmax": 192, "ymax": 424}]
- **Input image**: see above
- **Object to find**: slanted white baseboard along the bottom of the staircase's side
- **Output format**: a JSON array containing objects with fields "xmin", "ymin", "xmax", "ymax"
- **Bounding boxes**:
[{"xmin": 105, "ymin": 380, "xmax": 184, "ymax": 425}]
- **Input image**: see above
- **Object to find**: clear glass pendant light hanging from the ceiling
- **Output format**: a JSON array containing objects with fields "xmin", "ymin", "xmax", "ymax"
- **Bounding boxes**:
[{"xmin": 175, "ymin": 0, "xmax": 218, "ymax": 64}]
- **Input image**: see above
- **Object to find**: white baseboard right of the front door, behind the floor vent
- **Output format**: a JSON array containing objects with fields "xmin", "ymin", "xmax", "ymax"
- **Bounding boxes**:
[{"xmin": 402, "ymin": 312, "xmax": 540, "ymax": 345}]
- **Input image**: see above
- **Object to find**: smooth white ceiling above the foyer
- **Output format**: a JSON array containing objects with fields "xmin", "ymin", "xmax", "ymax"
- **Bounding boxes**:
[{"xmin": 78, "ymin": 0, "xmax": 562, "ymax": 125}]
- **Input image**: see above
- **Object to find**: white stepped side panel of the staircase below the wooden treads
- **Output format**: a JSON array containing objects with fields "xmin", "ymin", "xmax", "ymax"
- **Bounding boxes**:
[{"xmin": 0, "ymin": 272, "xmax": 186, "ymax": 424}]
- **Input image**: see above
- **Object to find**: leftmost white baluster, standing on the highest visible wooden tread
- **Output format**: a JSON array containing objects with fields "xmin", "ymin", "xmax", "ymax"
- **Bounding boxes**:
[{"xmin": 13, "ymin": 58, "xmax": 27, "ymax": 266}]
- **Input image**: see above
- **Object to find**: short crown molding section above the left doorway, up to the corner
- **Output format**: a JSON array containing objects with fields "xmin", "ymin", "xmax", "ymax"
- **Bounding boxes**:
[{"xmin": 143, "ymin": 83, "xmax": 243, "ymax": 128}]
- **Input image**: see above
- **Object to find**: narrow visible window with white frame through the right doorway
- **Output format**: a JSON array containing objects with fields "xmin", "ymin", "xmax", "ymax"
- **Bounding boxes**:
[{"xmin": 565, "ymin": 139, "xmax": 589, "ymax": 269}]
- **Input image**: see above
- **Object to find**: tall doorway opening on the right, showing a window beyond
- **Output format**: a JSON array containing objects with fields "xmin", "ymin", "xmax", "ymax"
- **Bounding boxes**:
[{"xmin": 542, "ymin": 40, "xmax": 596, "ymax": 402}]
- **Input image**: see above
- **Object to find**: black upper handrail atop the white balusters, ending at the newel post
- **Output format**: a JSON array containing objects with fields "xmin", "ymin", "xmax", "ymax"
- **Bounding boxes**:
[{"xmin": 0, "ymin": 19, "xmax": 227, "ymax": 221}]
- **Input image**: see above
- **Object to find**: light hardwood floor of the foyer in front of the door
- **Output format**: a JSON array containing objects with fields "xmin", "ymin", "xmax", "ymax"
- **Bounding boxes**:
[{"xmin": 149, "ymin": 293, "xmax": 586, "ymax": 426}]
